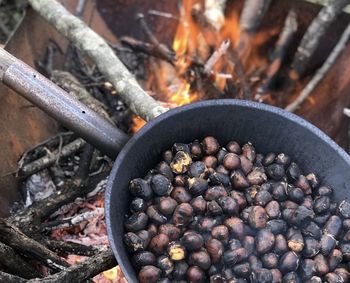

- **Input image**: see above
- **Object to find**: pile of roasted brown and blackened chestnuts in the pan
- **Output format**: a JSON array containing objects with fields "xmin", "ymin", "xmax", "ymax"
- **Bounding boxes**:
[{"xmin": 124, "ymin": 136, "xmax": 350, "ymax": 283}]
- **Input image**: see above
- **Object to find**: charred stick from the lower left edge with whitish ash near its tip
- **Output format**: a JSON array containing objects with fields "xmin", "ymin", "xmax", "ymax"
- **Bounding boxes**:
[{"xmin": 0, "ymin": 219, "xmax": 69, "ymax": 271}]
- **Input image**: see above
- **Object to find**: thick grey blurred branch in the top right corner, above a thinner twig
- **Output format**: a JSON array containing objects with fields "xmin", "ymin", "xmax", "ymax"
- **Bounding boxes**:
[{"xmin": 290, "ymin": 0, "xmax": 350, "ymax": 80}]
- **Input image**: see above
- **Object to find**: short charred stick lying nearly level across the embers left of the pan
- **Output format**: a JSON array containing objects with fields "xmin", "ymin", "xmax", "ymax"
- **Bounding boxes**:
[{"xmin": 42, "ymin": 240, "xmax": 101, "ymax": 258}]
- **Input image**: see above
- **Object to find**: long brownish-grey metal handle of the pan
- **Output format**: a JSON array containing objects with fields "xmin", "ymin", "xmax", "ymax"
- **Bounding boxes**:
[{"xmin": 0, "ymin": 48, "xmax": 129, "ymax": 158}]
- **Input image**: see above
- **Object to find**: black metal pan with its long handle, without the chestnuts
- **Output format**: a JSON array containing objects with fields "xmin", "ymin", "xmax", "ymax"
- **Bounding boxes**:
[{"xmin": 0, "ymin": 48, "xmax": 350, "ymax": 282}]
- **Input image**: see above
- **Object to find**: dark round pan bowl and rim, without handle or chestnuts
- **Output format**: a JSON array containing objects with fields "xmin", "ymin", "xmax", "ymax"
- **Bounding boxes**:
[{"xmin": 105, "ymin": 99, "xmax": 350, "ymax": 282}]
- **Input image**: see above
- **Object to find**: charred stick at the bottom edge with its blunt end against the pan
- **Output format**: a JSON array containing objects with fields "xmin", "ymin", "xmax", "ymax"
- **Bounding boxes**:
[{"xmin": 27, "ymin": 249, "xmax": 117, "ymax": 283}]
